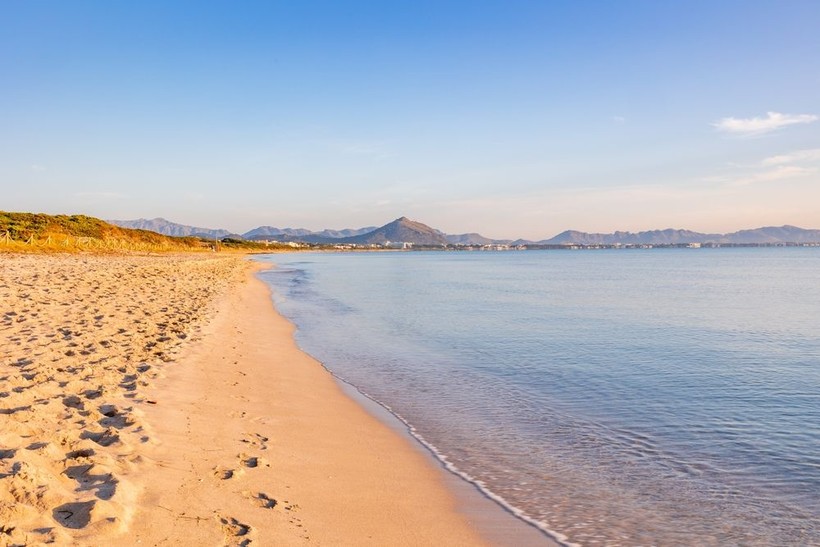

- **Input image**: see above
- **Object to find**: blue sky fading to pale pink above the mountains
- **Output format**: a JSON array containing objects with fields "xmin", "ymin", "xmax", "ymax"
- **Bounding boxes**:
[{"xmin": 0, "ymin": 0, "xmax": 820, "ymax": 240}]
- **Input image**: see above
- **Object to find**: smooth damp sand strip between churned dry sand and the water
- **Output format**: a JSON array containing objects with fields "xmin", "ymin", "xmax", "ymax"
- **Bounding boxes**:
[{"xmin": 121, "ymin": 266, "xmax": 494, "ymax": 545}]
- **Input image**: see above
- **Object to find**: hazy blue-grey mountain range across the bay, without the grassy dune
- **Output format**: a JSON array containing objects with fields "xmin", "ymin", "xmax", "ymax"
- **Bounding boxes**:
[{"xmin": 109, "ymin": 217, "xmax": 820, "ymax": 246}]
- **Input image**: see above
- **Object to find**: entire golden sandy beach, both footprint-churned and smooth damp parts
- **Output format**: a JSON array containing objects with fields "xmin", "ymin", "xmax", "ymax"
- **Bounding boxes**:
[{"xmin": 0, "ymin": 255, "xmax": 544, "ymax": 545}]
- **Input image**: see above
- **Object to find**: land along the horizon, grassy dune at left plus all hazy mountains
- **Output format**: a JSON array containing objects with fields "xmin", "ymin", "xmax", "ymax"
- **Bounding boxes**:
[{"xmin": 0, "ymin": 211, "xmax": 820, "ymax": 253}]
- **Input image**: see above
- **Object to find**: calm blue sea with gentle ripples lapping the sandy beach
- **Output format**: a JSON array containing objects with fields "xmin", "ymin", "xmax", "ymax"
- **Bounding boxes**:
[{"xmin": 261, "ymin": 248, "xmax": 820, "ymax": 545}]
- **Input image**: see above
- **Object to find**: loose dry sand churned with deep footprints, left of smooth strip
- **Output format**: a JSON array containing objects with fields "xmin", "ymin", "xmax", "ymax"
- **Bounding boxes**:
[{"xmin": 0, "ymin": 255, "xmax": 247, "ymax": 545}]
